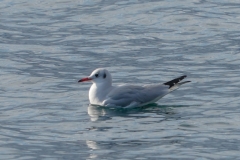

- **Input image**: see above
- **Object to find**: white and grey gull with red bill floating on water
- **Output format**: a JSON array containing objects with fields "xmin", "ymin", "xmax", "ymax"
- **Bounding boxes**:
[{"xmin": 78, "ymin": 68, "xmax": 190, "ymax": 108}]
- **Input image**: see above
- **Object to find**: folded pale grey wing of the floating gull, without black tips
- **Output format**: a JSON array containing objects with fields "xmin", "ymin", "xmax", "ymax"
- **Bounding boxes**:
[{"xmin": 103, "ymin": 85, "xmax": 168, "ymax": 107}]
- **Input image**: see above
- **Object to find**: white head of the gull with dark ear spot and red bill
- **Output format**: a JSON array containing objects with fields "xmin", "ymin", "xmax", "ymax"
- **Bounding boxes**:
[{"xmin": 78, "ymin": 68, "xmax": 112, "ymax": 85}]
